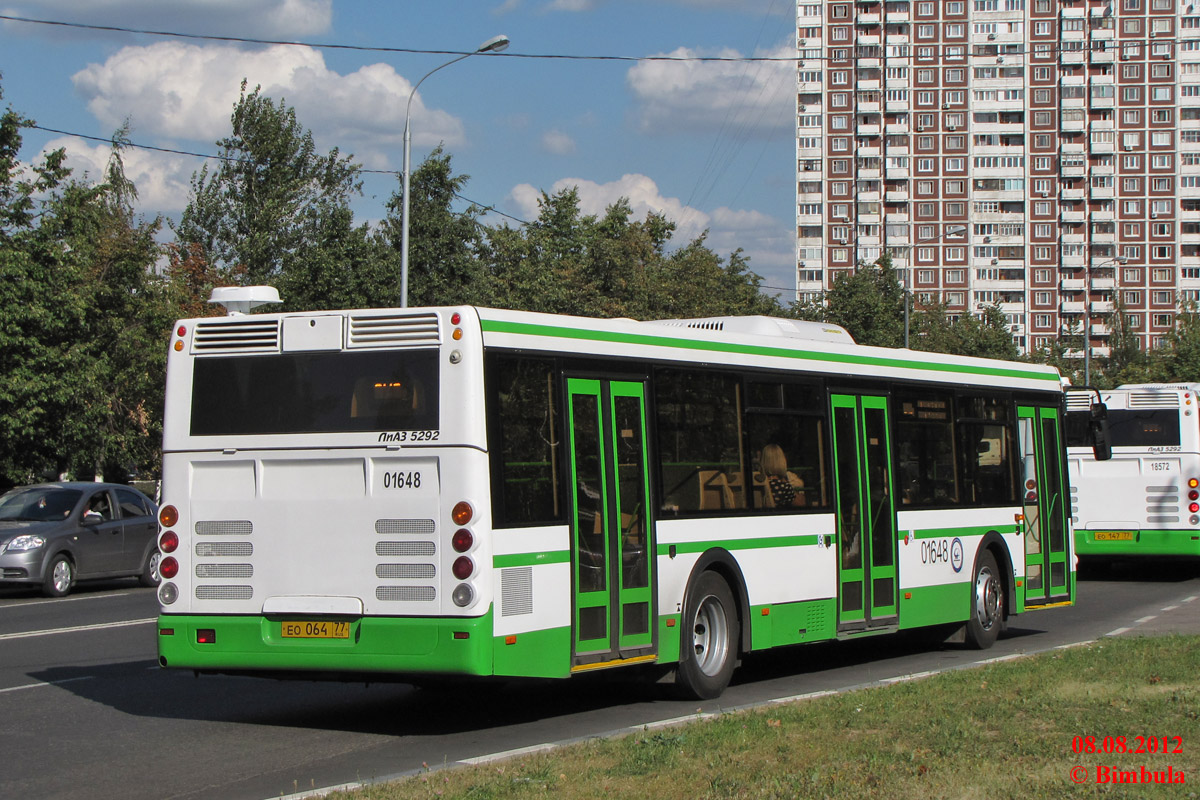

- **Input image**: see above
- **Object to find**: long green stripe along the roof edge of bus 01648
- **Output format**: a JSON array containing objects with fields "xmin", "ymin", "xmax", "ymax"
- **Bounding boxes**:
[{"xmin": 480, "ymin": 319, "xmax": 1058, "ymax": 386}]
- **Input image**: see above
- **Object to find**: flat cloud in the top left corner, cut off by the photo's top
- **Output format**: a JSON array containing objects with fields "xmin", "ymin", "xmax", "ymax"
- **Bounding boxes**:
[{"xmin": 3, "ymin": 0, "xmax": 334, "ymax": 37}]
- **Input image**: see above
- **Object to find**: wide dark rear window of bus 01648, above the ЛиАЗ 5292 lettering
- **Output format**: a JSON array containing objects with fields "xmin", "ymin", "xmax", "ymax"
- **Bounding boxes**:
[{"xmin": 191, "ymin": 350, "xmax": 438, "ymax": 437}]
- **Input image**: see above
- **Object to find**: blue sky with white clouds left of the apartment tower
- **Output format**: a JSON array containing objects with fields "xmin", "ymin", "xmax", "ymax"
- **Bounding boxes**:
[{"xmin": 0, "ymin": 0, "xmax": 796, "ymax": 297}]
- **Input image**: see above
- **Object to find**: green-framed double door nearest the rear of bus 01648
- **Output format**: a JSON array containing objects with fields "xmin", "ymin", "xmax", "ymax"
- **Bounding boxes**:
[{"xmin": 566, "ymin": 378, "xmax": 654, "ymax": 670}]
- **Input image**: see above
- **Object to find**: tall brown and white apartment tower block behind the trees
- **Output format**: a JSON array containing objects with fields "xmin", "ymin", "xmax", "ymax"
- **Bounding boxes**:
[{"xmin": 796, "ymin": 0, "xmax": 1200, "ymax": 355}]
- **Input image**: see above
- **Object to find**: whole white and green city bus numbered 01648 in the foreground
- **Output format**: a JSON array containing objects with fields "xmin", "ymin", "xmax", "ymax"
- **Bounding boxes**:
[{"xmin": 158, "ymin": 290, "xmax": 1075, "ymax": 697}]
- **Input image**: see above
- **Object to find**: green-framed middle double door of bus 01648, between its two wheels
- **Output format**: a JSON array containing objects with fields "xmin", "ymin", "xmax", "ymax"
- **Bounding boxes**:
[{"xmin": 832, "ymin": 395, "xmax": 898, "ymax": 631}]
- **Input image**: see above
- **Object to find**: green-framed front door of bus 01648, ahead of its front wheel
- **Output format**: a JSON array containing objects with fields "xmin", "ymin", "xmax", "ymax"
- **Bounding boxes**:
[{"xmin": 1016, "ymin": 405, "xmax": 1070, "ymax": 606}]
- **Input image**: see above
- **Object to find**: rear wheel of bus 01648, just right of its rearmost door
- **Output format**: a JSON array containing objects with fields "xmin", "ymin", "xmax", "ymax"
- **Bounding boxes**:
[{"xmin": 676, "ymin": 572, "xmax": 740, "ymax": 700}]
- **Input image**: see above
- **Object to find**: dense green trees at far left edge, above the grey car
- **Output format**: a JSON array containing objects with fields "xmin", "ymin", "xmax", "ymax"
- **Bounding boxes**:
[{"xmin": 0, "ymin": 90, "xmax": 166, "ymax": 482}]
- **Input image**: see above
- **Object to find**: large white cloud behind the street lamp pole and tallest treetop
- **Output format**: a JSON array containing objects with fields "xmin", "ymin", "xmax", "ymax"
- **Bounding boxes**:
[{"xmin": 73, "ymin": 42, "xmax": 464, "ymax": 167}]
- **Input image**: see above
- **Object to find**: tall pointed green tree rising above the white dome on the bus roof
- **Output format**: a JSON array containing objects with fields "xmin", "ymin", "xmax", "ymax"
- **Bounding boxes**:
[{"xmin": 175, "ymin": 82, "xmax": 365, "ymax": 289}]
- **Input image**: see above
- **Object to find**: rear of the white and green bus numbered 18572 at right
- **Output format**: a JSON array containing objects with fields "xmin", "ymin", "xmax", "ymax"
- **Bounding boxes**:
[{"xmin": 1067, "ymin": 384, "xmax": 1200, "ymax": 558}]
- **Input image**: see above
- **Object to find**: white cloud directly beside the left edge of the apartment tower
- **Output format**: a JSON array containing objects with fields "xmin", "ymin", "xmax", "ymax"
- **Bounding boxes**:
[{"xmin": 625, "ymin": 44, "xmax": 796, "ymax": 138}]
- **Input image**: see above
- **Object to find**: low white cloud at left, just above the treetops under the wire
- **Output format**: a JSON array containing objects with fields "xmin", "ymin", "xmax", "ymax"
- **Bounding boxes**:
[{"xmin": 42, "ymin": 137, "xmax": 196, "ymax": 213}]
